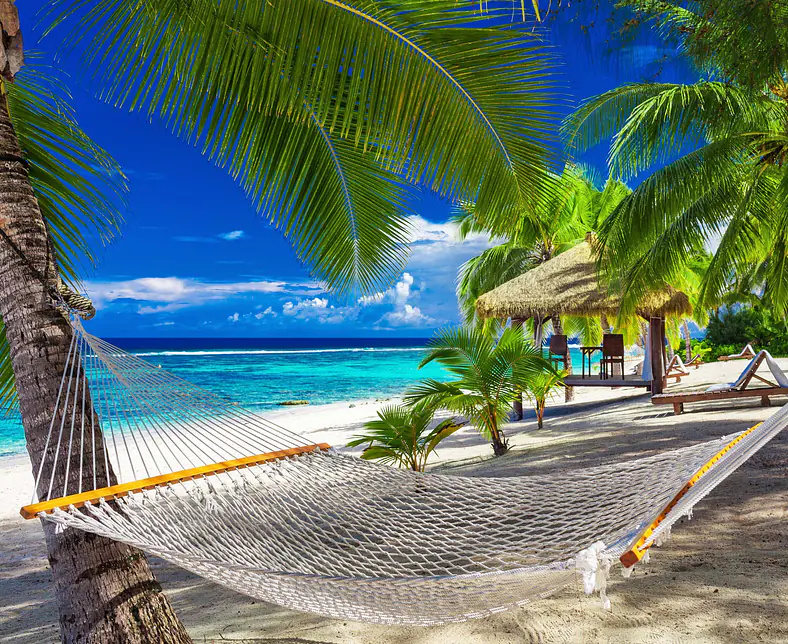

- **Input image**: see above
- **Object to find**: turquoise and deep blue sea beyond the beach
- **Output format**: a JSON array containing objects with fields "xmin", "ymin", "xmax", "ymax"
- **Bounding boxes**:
[{"xmin": 0, "ymin": 338, "xmax": 592, "ymax": 456}]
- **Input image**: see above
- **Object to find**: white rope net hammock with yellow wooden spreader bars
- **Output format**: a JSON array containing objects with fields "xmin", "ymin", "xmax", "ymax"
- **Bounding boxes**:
[{"xmin": 22, "ymin": 319, "xmax": 788, "ymax": 625}]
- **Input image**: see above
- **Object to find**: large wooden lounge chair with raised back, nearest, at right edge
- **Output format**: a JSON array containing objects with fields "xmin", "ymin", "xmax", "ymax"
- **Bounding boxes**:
[{"xmin": 651, "ymin": 351, "xmax": 788, "ymax": 415}]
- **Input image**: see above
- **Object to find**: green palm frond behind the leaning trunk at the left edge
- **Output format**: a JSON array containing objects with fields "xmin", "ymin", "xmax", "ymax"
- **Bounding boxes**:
[{"xmin": 0, "ymin": 64, "xmax": 128, "ymax": 408}]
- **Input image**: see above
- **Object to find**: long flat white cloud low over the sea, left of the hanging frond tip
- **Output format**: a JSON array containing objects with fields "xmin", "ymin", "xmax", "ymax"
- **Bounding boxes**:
[{"xmin": 86, "ymin": 277, "xmax": 322, "ymax": 314}]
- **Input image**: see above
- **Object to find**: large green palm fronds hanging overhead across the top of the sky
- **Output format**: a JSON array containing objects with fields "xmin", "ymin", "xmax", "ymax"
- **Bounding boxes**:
[{"xmin": 50, "ymin": 0, "xmax": 552, "ymax": 291}]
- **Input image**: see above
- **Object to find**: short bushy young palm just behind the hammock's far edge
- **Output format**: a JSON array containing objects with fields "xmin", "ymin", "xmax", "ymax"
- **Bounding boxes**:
[{"xmin": 348, "ymin": 402, "xmax": 464, "ymax": 472}]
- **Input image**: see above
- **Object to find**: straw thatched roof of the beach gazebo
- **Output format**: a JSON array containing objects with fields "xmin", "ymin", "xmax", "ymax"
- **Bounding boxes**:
[{"xmin": 476, "ymin": 241, "xmax": 692, "ymax": 319}]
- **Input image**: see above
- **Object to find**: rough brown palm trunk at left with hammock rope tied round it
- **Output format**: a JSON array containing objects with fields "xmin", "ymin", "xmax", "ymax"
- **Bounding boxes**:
[{"xmin": 0, "ymin": 73, "xmax": 191, "ymax": 644}]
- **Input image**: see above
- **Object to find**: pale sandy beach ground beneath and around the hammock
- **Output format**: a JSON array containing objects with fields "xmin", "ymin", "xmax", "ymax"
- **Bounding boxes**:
[{"xmin": 0, "ymin": 360, "xmax": 788, "ymax": 644}]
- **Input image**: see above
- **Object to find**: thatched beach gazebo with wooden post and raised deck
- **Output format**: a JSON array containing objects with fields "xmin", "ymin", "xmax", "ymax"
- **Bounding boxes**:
[{"xmin": 476, "ymin": 236, "xmax": 692, "ymax": 393}]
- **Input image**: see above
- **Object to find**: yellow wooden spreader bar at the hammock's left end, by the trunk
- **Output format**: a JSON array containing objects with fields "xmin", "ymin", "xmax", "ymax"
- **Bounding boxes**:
[{"xmin": 19, "ymin": 443, "xmax": 331, "ymax": 519}]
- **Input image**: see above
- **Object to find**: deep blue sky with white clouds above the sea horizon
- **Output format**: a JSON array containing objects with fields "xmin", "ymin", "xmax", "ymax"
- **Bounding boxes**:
[{"xmin": 18, "ymin": 0, "xmax": 689, "ymax": 337}]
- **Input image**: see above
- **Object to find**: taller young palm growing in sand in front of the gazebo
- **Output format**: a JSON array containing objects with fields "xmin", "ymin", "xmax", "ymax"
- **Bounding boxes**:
[{"xmin": 405, "ymin": 327, "xmax": 552, "ymax": 456}]
